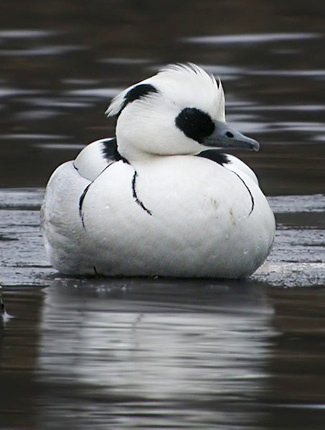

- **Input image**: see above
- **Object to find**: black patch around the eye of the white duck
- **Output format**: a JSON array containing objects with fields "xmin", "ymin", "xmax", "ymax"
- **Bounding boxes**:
[{"xmin": 175, "ymin": 108, "xmax": 215, "ymax": 143}]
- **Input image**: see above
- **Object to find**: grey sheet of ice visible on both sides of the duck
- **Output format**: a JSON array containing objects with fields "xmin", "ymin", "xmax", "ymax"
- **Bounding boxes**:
[{"xmin": 0, "ymin": 188, "xmax": 325, "ymax": 287}]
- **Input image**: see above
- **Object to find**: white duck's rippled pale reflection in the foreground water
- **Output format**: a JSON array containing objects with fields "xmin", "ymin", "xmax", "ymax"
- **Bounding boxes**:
[{"xmin": 11, "ymin": 280, "xmax": 275, "ymax": 429}]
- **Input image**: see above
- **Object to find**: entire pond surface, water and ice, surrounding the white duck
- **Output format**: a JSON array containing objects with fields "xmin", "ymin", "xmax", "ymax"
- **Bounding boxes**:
[{"xmin": 0, "ymin": 0, "xmax": 325, "ymax": 430}]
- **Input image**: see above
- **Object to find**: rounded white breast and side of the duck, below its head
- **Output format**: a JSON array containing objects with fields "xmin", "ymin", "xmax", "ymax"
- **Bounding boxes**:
[{"xmin": 82, "ymin": 156, "xmax": 274, "ymax": 277}]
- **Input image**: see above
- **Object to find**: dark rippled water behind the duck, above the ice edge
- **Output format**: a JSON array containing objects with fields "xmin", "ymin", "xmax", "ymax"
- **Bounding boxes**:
[{"xmin": 0, "ymin": 0, "xmax": 325, "ymax": 194}]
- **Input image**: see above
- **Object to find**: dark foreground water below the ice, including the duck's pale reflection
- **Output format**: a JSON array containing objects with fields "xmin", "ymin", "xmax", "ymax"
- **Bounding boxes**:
[{"xmin": 0, "ymin": 278, "xmax": 325, "ymax": 430}]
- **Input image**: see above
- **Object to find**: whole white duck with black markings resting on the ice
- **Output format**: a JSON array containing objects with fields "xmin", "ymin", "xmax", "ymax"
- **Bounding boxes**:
[{"xmin": 42, "ymin": 65, "xmax": 275, "ymax": 278}]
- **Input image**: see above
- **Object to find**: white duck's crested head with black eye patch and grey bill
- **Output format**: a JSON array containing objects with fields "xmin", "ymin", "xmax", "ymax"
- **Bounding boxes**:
[{"xmin": 106, "ymin": 64, "xmax": 259, "ymax": 161}]
